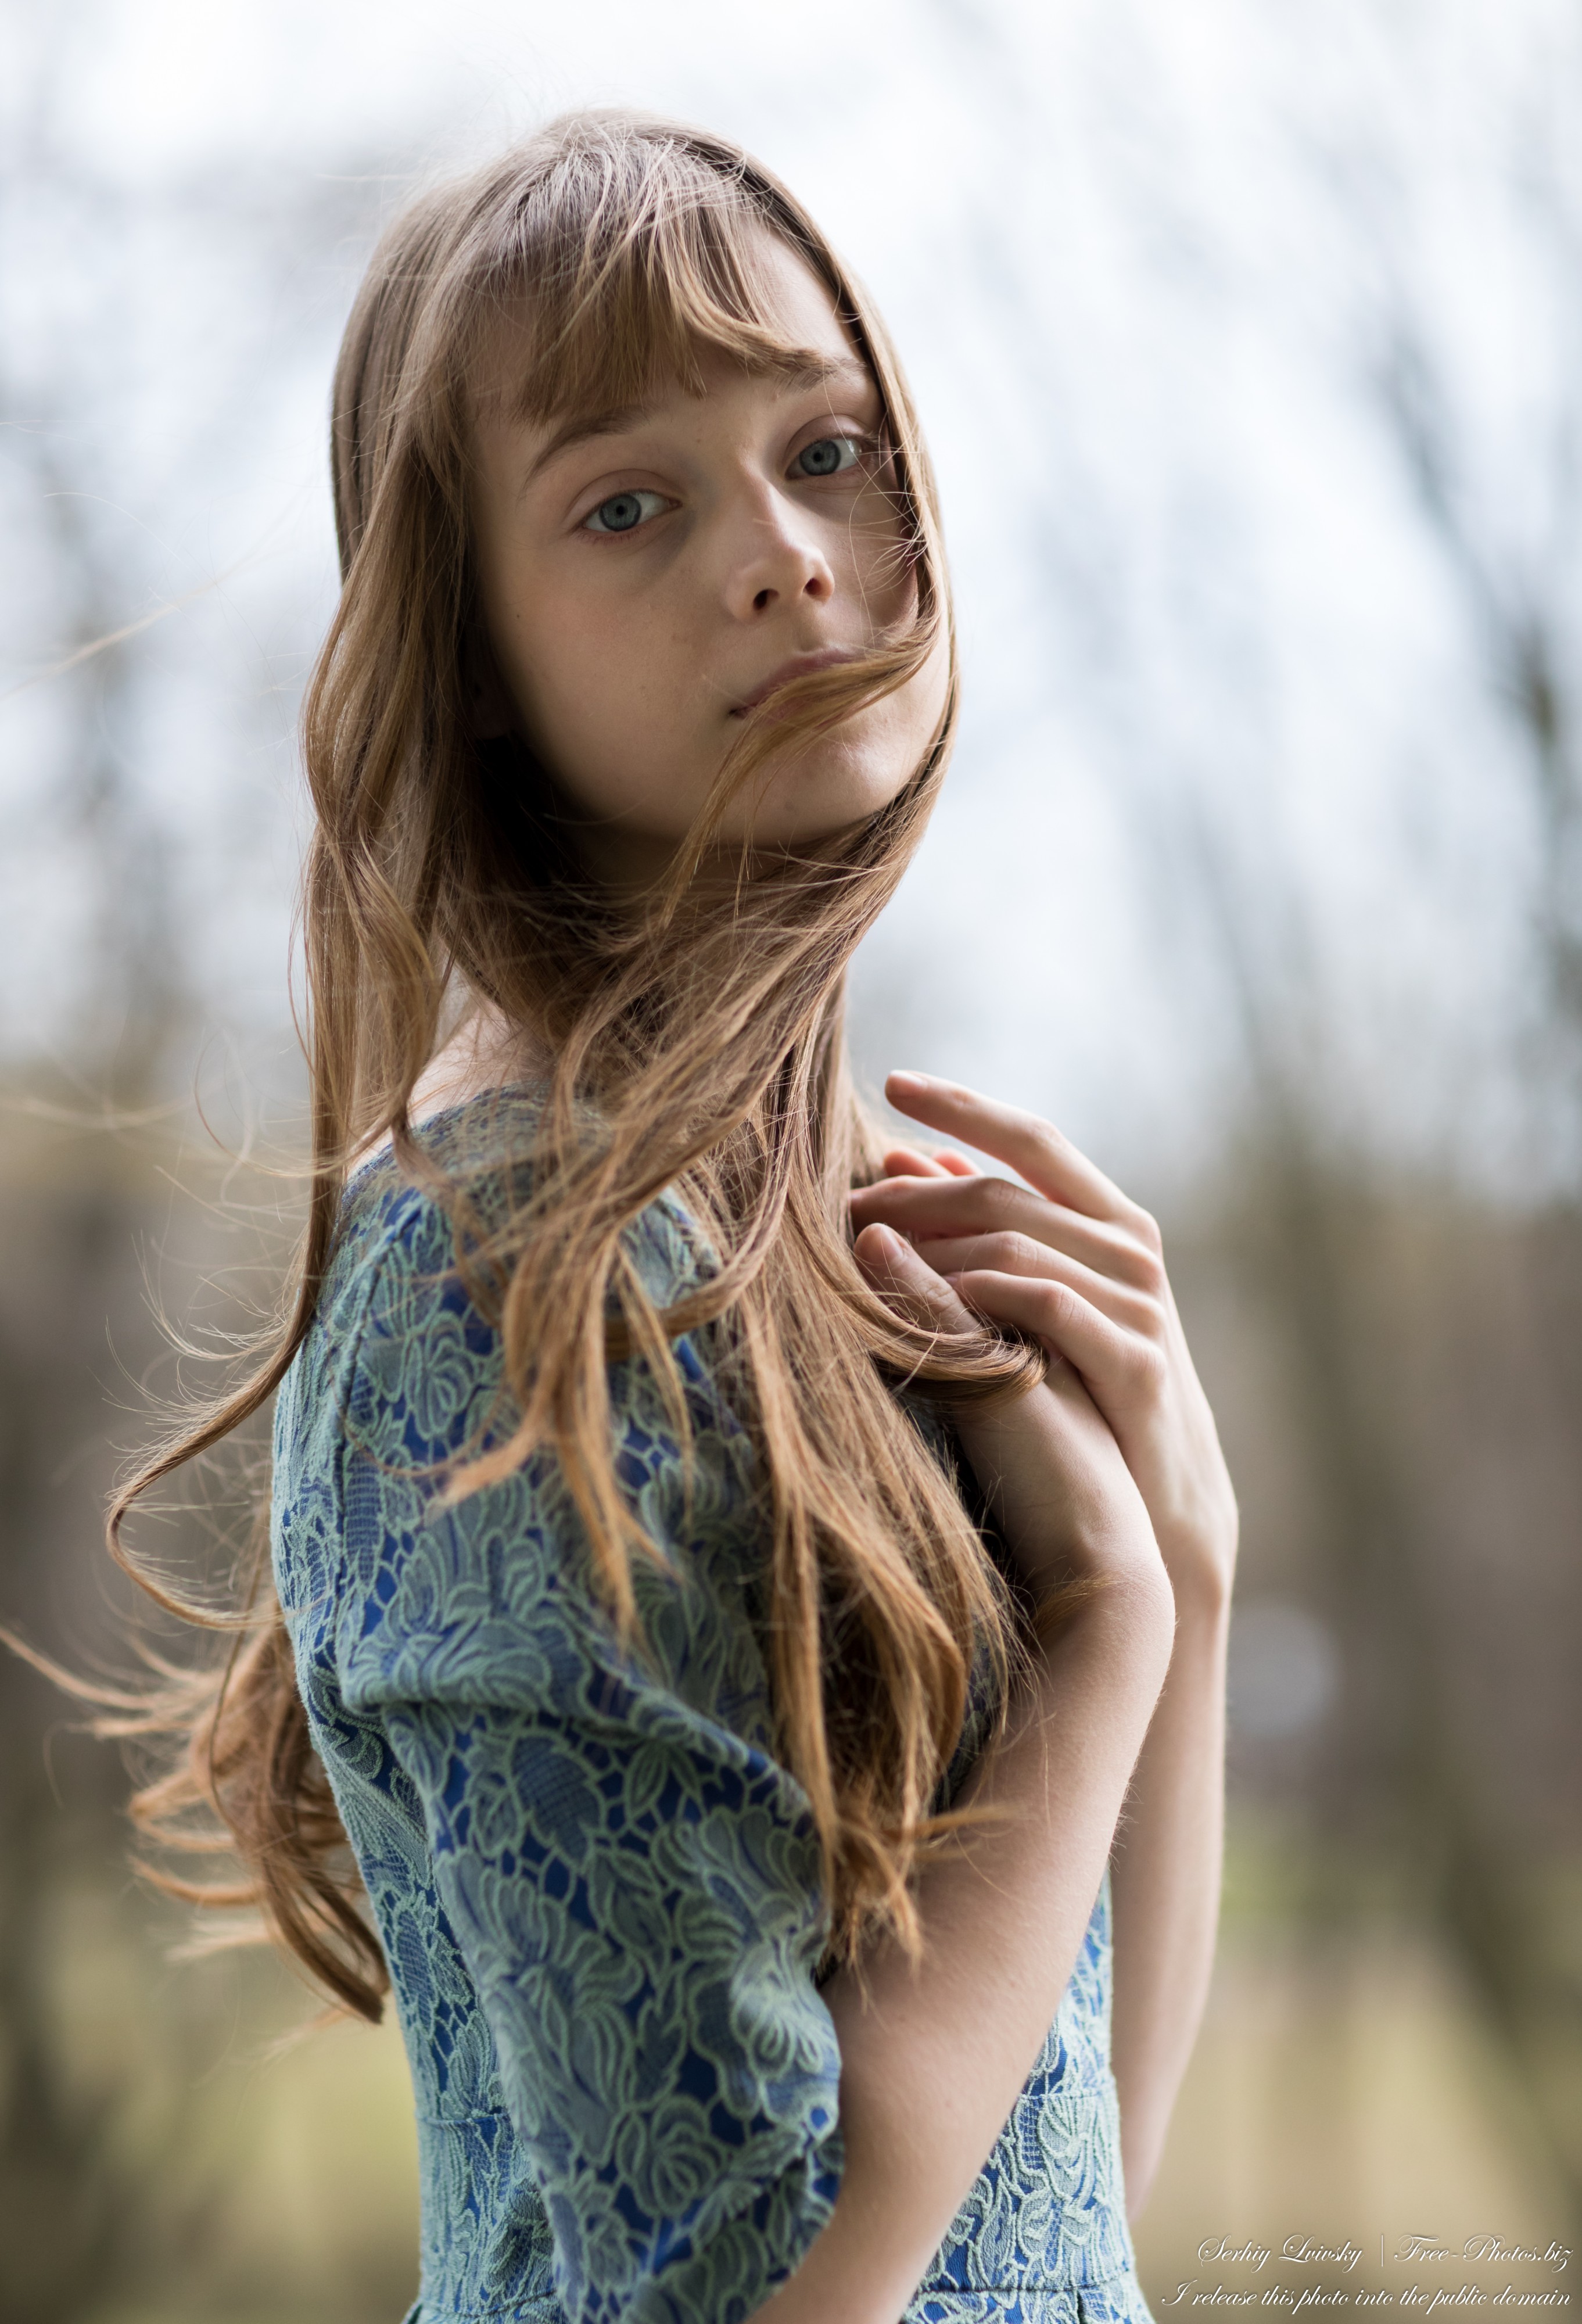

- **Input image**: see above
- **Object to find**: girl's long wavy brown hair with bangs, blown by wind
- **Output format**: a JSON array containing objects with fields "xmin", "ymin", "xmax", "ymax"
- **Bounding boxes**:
[{"xmin": 107, "ymin": 112, "xmax": 1041, "ymax": 2017}]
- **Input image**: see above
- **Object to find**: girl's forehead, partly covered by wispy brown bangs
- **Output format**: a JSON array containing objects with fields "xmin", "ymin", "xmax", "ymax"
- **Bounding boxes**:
[{"xmin": 472, "ymin": 225, "xmax": 873, "ymax": 442}]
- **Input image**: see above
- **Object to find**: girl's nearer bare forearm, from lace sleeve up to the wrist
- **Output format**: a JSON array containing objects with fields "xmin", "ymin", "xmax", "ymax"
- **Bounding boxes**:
[{"xmin": 760, "ymin": 1576, "xmax": 1168, "ymax": 2324}]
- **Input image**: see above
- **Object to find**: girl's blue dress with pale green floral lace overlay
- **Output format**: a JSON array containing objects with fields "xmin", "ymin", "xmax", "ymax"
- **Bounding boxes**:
[{"xmin": 274, "ymin": 1092, "xmax": 1150, "ymax": 2324}]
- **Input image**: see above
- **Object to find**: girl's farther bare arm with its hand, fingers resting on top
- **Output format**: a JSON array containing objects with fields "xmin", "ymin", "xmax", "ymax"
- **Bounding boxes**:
[{"xmin": 855, "ymin": 1076, "xmax": 1236, "ymax": 2215}]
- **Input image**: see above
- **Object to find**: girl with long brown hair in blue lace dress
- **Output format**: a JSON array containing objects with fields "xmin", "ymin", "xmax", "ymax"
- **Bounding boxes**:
[{"xmin": 112, "ymin": 114, "xmax": 1236, "ymax": 2324}]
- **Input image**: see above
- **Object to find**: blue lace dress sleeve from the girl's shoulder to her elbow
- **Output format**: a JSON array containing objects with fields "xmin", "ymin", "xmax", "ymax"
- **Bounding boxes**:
[{"xmin": 337, "ymin": 1213, "xmax": 841, "ymax": 2324}]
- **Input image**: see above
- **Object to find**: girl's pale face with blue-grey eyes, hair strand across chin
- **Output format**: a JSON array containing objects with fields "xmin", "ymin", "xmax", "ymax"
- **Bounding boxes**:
[{"xmin": 462, "ymin": 232, "xmax": 948, "ymax": 883}]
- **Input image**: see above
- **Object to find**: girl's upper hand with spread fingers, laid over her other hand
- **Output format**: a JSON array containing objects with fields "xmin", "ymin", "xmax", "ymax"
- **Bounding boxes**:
[{"xmin": 852, "ymin": 1074, "xmax": 1236, "ymax": 1599}]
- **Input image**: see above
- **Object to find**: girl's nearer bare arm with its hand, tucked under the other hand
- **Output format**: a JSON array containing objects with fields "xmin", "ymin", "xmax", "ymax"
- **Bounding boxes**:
[{"xmin": 760, "ymin": 1227, "xmax": 1173, "ymax": 2324}]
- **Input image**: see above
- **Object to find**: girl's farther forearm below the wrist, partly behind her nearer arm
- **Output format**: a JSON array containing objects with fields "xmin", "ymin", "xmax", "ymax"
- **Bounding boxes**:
[{"xmin": 1110, "ymin": 1580, "xmax": 1229, "ymax": 2217}]
